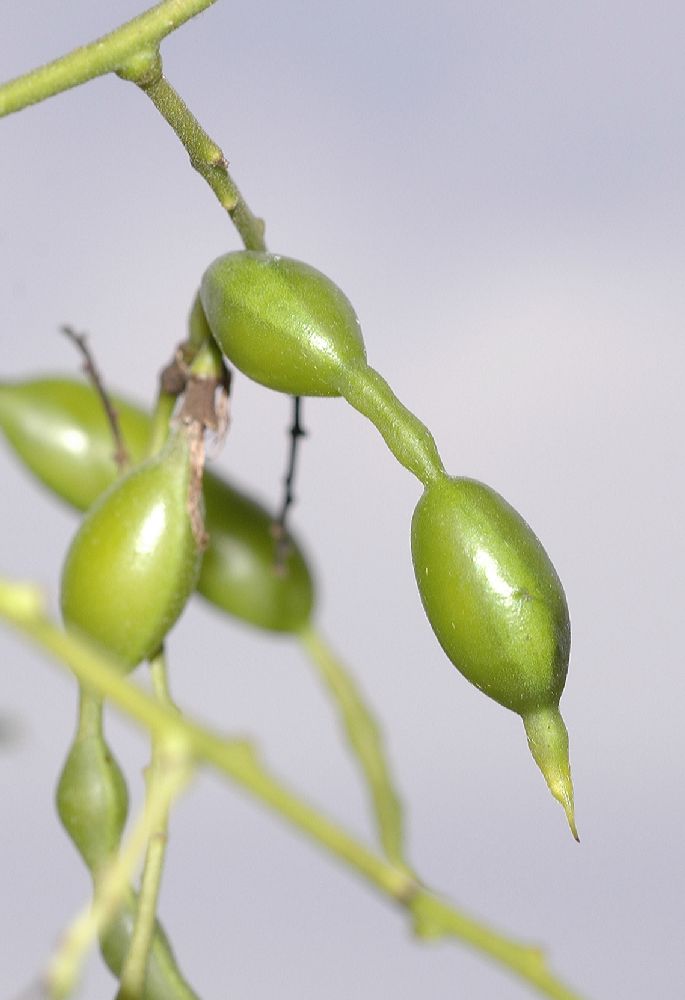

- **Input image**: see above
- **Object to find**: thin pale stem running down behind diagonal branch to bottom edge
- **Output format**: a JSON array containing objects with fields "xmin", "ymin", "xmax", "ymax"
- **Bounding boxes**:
[{"xmin": 116, "ymin": 649, "xmax": 175, "ymax": 1000}]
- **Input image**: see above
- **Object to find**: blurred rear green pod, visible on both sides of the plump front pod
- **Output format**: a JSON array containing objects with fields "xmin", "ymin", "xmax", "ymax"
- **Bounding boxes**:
[{"xmin": 0, "ymin": 378, "xmax": 314, "ymax": 632}]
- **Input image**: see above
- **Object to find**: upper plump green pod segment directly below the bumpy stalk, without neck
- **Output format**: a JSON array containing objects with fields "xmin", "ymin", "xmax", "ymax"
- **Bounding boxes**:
[{"xmin": 200, "ymin": 250, "xmax": 366, "ymax": 396}]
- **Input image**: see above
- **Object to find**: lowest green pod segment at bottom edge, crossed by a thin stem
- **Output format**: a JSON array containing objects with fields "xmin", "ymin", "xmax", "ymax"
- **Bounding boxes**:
[{"xmin": 100, "ymin": 889, "xmax": 199, "ymax": 1000}]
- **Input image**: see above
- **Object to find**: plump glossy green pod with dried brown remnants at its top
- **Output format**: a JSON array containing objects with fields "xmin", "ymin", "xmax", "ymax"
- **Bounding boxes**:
[{"xmin": 61, "ymin": 431, "xmax": 202, "ymax": 669}]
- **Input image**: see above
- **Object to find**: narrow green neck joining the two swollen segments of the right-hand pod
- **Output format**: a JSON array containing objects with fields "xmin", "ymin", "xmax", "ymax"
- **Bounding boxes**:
[{"xmin": 338, "ymin": 365, "xmax": 445, "ymax": 486}]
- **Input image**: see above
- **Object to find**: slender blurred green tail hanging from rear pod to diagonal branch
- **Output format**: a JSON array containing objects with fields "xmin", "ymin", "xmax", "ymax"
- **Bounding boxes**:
[{"xmin": 299, "ymin": 625, "xmax": 409, "ymax": 871}]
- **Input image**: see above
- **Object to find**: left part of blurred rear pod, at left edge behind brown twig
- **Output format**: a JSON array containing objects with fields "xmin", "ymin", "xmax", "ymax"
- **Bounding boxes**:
[{"xmin": 0, "ymin": 378, "xmax": 150, "ymax": 510}]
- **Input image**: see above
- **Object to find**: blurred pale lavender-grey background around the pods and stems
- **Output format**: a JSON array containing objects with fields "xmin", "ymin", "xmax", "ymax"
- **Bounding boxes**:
[{"xmin": 0, "ymin": 0, "xmax": 685, "ymax": 1000}]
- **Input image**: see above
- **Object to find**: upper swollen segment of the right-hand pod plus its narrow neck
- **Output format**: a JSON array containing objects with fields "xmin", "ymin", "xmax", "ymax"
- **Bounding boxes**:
[{"xmin": 198, "ymin": 250, "xmax": 444, "ymax": 483}]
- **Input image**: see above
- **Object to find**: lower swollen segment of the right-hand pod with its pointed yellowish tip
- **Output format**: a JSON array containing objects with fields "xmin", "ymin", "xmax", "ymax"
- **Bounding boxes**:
[{"xmin": 412, "ymin": 476, "xmax": 577, "ymax": 836}]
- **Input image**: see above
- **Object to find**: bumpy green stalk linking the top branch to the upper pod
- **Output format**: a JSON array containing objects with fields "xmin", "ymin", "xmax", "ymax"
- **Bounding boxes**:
[{"xmin": 127, "ymin": 69, "xmax": 266, "ymax": 250}]
